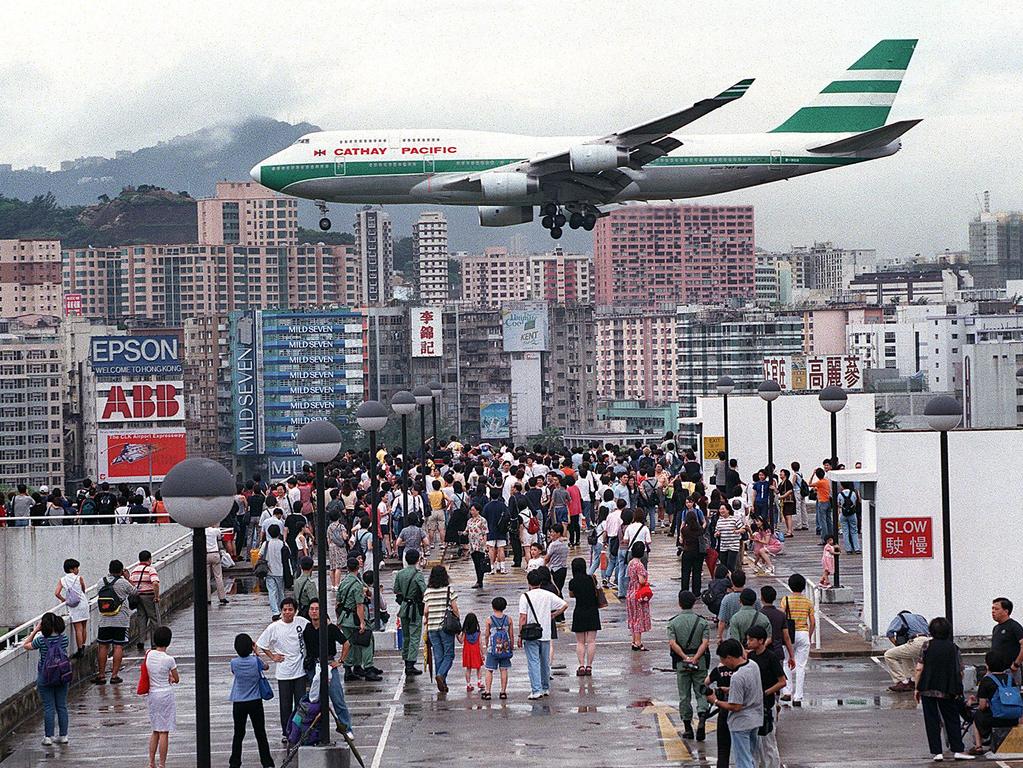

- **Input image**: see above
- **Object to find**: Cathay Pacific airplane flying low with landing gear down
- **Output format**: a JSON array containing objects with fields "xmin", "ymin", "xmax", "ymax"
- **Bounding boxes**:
[{"xmin": 251, "ymin": 40, "xmax": 920, "ymax": 238}]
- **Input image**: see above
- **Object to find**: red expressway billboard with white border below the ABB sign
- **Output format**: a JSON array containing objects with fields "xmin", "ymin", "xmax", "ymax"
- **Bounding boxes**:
[{"xmin": 96, "ymin": 428, "xmax": 186, "ymax": 483}]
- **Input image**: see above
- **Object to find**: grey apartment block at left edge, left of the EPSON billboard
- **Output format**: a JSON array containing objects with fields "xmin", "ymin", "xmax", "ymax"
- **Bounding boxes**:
[{"xmin": 0, "ymin": 320, "xmax": 64, "ymax": 488}]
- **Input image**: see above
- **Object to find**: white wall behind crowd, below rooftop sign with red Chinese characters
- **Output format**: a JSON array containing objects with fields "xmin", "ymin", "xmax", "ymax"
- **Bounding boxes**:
[{"xmin": 697, "ymin": 393, "xmax": 874, "ymax": 483}]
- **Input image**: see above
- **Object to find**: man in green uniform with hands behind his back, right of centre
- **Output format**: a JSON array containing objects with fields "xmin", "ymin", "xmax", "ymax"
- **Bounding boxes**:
[{"xmin": 668, "ymin": 590, "xmax": 710, "ymax": 741}]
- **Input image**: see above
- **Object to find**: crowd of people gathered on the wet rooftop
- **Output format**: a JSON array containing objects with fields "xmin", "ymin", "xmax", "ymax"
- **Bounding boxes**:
[{"xmin": 14, "ymin": 434, "xmax": 1023, "ymax": 768}]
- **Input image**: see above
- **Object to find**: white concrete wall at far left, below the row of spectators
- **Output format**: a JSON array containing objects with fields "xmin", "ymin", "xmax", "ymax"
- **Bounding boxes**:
[{"xmin": 0, "ymin": 524, "xmax": 187, "ymax": 627}]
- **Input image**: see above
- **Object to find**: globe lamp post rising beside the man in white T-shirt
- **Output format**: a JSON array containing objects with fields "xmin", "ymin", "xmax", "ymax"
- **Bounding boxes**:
[{"xmin": 296, "ymin": 419, "xmax": 342, "ymax": 747}]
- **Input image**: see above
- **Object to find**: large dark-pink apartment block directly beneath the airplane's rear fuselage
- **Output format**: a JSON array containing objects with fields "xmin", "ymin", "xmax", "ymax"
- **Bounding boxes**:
[{"xmin": 593, "ymin": 205, "xmax": 756, "ymax": 306}]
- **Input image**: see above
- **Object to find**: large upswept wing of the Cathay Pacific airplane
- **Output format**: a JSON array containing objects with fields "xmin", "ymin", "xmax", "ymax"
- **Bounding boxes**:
[{"xmin": 444, "ymin": 78, "xmax": 753, "ymax": 199}]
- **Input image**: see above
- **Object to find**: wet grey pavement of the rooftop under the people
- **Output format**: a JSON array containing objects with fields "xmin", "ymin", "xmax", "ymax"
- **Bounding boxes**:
[{"xmin": 0, "ymin": 532, "xmax": 1023, "ymax": 768}]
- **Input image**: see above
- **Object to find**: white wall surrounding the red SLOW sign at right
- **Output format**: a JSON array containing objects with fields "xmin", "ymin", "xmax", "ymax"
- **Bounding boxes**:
[{"xmin": 863, "ymin": 430, "xmax": 1023, "ymax": 636}]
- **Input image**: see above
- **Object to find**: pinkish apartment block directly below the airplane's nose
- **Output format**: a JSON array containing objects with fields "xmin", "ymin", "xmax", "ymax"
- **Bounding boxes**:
[{"xmin": 197, "ymin": 181, "xmax": 299, "ymax": 246}]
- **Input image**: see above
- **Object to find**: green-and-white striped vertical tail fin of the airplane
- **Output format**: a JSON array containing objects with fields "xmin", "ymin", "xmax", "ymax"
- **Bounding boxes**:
[{"xmin": 771, "ymin": 40, "xmax": 917, "ymax": 133}]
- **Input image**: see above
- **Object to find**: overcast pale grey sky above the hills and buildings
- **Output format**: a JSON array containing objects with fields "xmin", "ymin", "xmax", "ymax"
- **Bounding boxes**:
[{"xmin": 0, "ymin": 0, "xmax": 1023, "ymax": 255}]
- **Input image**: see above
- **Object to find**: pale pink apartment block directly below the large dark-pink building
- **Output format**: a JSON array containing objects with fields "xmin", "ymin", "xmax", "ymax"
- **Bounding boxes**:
[{"xmin": 595, "ymin": 307, "xmax": 678, "ymax": 405}]
